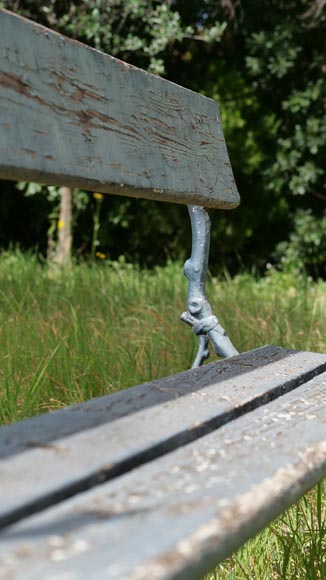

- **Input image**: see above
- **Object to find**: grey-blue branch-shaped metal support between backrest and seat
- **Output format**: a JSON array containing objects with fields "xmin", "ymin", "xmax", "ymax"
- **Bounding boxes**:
[{"xmin": 180, "ymin": 205, "xmax": 239, "ymax": 368}]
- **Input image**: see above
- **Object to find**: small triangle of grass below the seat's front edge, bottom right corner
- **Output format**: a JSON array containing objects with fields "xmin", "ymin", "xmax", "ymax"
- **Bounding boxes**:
[{"xmin": 204, "ymin": 482, "xmax": 326, "ymax": 580}]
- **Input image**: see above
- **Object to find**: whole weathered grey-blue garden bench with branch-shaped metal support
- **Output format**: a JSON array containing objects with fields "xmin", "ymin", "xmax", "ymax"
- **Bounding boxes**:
[{"xmin": 0, "ymin": 11, "xmax": 326, "ymax": 580}]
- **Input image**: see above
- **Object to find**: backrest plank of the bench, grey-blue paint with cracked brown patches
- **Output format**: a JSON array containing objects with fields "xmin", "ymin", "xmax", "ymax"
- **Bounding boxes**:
[{"xmin": 0, "ymin": 10, "xmax": 239, "ymax": 208}]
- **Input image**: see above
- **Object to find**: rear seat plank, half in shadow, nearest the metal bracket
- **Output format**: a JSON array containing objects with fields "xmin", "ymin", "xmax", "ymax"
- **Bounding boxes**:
[{"xmin": 0, "ymin": 347, "xmax": 326, "ymax": 526}]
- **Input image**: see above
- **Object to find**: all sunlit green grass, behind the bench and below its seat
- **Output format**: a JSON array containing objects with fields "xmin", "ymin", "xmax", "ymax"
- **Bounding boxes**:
[{"xmin": 0, "ymin": 252, "xmax": 326, "ymax": 580}]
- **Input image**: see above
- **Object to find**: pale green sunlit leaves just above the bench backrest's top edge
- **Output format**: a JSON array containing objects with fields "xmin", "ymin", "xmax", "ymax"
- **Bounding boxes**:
[{"xmin": 58, "ymin": 0, "xmax": 188, "ymax": 74}]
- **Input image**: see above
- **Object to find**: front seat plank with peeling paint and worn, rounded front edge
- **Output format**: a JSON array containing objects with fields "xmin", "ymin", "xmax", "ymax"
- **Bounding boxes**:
[{"xmin": 0, "ymin": 373, "xmax": 326, "ymax": 580}]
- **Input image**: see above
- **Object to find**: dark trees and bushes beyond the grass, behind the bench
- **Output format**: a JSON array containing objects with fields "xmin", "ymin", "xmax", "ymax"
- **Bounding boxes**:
[{"xmin": 0, "ymin": 0, "xmax": 326, "ymax": 278}]
